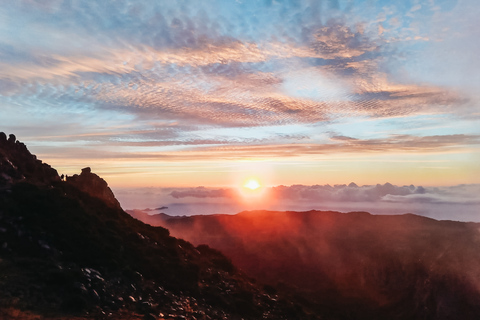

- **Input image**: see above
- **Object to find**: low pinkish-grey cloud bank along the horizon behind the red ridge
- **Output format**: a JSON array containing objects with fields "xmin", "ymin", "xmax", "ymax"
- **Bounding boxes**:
[{"xmin": 114, "ymin": 183, "xmax": 480, "ymax": 222}]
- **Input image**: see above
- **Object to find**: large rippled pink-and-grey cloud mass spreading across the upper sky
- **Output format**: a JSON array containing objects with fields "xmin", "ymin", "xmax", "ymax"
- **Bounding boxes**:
[{"xmin": 0, "ymin": 1, "xmax": 463, "ymax": 127}]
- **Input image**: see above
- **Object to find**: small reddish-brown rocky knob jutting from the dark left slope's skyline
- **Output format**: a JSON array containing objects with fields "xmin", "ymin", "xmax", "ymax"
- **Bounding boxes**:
[{"xmin": 66, "ymin": 167, "xmax": 120, "ymax": 208}]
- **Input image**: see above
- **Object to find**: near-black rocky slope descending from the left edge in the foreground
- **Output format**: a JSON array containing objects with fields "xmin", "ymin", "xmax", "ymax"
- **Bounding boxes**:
[{"xmin": 0, "ymin": 134, "xmax": 313, "ymax": 319}]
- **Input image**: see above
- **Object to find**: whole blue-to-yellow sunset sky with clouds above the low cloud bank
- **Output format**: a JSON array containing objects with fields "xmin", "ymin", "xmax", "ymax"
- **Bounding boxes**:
[{"xmin": 0, "ymin": 0, "xmax": 480, "ymax": 220}]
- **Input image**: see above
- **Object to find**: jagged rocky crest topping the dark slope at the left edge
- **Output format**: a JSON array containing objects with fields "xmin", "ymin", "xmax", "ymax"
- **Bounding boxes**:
[{"xmin": 0, "ymin": 132, "xmax": 60, "ymax": 188}]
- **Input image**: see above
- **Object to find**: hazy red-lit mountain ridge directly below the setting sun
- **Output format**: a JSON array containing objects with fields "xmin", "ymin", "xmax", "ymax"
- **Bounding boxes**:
[{"xmin": 140, "ymin": 211, "xmax": 480, "ymax": 319}]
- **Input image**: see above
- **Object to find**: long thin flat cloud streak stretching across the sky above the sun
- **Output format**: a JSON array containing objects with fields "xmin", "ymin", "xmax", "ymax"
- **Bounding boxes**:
[{"xmin": 25, "ymin": 133, "xmax": 480, "ymax": 162}]
